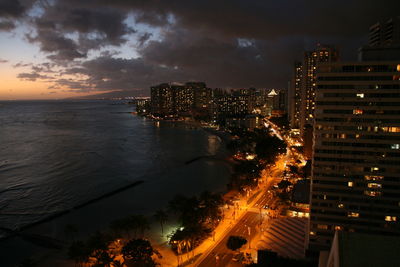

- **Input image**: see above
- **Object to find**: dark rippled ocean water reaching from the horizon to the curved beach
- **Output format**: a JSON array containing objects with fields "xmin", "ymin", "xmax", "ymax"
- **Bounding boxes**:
[{"xmin": 0, "ymin": 100, "xmax": 230, "ymax": 262}]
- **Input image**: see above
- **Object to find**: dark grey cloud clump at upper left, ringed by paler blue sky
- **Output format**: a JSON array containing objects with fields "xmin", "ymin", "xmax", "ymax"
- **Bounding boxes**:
[{"xmin": 28, "ymin": 1, "xmax": 134, "ymax": 61}]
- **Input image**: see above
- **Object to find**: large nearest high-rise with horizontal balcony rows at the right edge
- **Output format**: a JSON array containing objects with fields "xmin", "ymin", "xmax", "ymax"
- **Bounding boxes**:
[{"xmin": 309, "ymin": 61, "xmax": 400, "ymax": 250}]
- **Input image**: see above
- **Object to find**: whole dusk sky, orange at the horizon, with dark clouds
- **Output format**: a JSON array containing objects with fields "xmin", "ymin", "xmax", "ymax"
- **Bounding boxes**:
[{"xmin": 0, "ymin": 0, "xmax": 400, "ymax": 100}]
